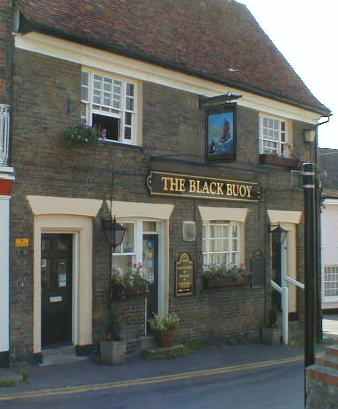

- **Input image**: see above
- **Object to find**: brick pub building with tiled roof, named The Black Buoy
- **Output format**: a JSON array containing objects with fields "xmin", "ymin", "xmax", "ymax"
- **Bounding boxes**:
[{"xmin": 0, "ymin": 0, "xmax": 330, "ymax": 362}]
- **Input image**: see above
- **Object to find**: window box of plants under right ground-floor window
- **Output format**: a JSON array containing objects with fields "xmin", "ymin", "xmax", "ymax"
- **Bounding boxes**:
[{"xmin": 203, "ymin": 265, "xmax": 251, "ymax": 289}]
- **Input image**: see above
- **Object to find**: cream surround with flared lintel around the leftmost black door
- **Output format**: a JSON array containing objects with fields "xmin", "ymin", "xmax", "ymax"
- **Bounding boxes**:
[{"xmin": 27, "ymin": 196, "xmax": 102, "ymax": 355}]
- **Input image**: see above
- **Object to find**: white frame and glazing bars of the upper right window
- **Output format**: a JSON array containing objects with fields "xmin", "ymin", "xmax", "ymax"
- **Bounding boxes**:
[{"xmin": 259, "ymin": 114, "xmax": 290, "ymax": 158}]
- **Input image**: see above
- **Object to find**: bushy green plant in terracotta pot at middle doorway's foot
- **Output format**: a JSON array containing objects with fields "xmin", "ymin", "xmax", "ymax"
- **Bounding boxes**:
[{"xmin": 149, "ymin": 313, "xmax": 180, "ymax": 348}]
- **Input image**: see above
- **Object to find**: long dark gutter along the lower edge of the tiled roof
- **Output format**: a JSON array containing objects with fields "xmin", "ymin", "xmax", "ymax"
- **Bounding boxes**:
[{"xmin": 14, "ymin": 10, "xmax": 331, "ymax": 116}]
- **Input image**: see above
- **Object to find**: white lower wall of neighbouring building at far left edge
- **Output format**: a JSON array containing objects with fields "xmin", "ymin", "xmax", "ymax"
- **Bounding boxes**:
[{"xmin": 0, "ymin": 196, "xmax": 10, "ymax": 352}]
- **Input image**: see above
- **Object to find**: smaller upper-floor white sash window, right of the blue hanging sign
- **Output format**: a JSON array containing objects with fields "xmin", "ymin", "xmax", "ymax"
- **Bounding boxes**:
[{"xmin": 259, "ymin": 115, "xmax": 289, "ymax": 158}]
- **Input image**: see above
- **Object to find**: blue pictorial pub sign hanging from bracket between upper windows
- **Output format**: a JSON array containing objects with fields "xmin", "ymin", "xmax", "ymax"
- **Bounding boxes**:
[{"xmin": 206, "ymin": 105, "xmax": 237, "ymax": 161}]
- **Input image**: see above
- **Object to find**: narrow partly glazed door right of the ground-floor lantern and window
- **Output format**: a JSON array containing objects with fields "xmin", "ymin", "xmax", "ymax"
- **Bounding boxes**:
[{"xmin": 143, "ymin": 234, "xmax": 158, "ymax": 318}]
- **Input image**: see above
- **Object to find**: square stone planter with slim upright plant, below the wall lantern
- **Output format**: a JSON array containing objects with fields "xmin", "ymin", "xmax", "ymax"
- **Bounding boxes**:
[{"xmin": 100, "ymin": 306, "xmax": 127, "ymax": 365}]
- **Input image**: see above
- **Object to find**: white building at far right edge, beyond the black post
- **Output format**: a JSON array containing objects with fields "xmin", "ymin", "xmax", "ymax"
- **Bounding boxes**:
[{"xmin": 321, "ymin": 199, "xmax": 338, "ymax": 309}]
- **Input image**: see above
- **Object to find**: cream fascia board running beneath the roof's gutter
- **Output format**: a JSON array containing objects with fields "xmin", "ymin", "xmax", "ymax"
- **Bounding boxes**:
[{"xmin": 15, "ymin": 33, "xmax": 321, "ymax": 124}]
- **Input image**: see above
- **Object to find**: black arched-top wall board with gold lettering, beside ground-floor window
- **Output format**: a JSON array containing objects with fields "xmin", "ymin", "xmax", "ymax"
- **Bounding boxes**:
[{"xmin": 176, "ymin": 253, "xmax": 194, "ymax": 297}]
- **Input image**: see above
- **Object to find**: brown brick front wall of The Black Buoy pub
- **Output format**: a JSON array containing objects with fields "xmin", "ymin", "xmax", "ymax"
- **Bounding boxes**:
[{"xmin": 11, "ymin": 50, "xmax": 312, "ymax": 356}]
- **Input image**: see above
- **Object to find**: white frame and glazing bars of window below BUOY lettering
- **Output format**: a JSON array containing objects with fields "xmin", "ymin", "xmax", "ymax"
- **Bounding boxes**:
[{"xmin": 202, "ymin": 220, "xmax": 243, "ymax": 268}]
